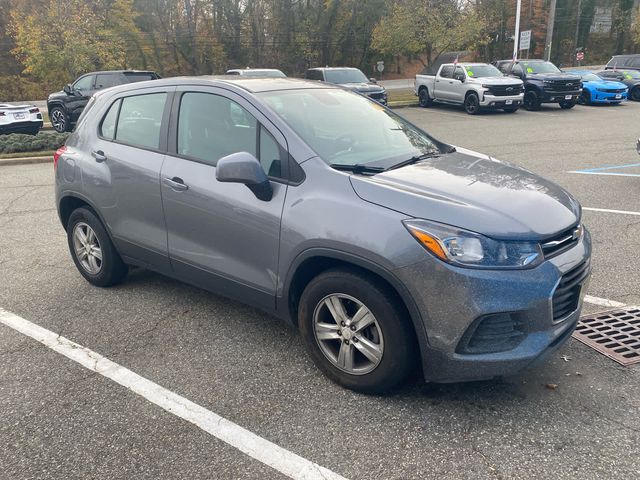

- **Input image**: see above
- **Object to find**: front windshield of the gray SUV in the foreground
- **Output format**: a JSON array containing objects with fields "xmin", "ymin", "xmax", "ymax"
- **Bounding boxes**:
[{"xmin": 259, "ymin": 88, "xmax": 440, "ymax": 168}]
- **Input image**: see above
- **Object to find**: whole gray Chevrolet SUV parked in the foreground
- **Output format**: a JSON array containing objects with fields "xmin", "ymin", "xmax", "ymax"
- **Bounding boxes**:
[{"xmin": 54, "ymin": 76, "xmax": 591, "ymax": 392}]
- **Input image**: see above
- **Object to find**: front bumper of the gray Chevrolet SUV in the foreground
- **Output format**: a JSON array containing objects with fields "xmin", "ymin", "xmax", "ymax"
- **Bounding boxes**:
[{"xmin": 395, "ymin": 230, "xmax": 591, "ymax": 382}]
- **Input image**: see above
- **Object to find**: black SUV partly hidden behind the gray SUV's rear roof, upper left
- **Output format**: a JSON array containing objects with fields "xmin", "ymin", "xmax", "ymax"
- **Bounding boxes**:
[{"xmin": 47, "ymin": 70, "xmax": 160, "ymax": 133}]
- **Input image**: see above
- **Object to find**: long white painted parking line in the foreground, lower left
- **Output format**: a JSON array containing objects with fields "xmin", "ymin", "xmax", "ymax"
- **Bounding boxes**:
[{"xmin": 0, "ymin": 308, "xmax": 346, "ymax": 480}]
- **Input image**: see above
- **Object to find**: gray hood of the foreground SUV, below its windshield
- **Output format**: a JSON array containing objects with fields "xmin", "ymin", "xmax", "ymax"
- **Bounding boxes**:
[{"xmin": 350, "ymin": 148, "xmax": 580, "ymax": 240}]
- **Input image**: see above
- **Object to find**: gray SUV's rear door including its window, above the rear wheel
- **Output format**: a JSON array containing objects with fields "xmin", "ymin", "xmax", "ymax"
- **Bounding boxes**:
[{"xmin": 83, "ymin": 87, "xmax": 175, "ymax": 272}]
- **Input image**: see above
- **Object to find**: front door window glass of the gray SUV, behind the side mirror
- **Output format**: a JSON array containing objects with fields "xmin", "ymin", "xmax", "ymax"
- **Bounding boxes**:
[{"xmin": 178, "ymin": 92, "xmax": 258, "ymax": 166}]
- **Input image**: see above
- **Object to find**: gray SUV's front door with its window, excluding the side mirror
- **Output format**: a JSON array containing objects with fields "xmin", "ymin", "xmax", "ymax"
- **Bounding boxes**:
[{"xmin": 161, "ymin": 87, "xmax": 287, "ymax": 309}]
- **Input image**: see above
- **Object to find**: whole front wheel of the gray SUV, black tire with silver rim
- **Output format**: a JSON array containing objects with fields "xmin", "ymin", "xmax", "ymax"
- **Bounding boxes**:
[{"xmin": 298, "ymin": 268, "xmax": 416, "ymax": 393}]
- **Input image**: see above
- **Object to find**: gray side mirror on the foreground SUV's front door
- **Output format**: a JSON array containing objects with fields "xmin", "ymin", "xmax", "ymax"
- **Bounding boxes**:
[{"xmin": 216, "ymin": 152, "xmax": 273, "ymax": 202}]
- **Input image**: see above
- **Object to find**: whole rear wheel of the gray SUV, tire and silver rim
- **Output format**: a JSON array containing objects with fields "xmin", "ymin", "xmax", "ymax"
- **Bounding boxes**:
[{"xmin": 67, "ymin": 207, "xmax": 128, "ymax": 287}]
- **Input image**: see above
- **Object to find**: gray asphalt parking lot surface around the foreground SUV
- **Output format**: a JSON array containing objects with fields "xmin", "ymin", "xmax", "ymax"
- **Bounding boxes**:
[{"xmin": 0, "ymin": 103, "xmax": 640, "ymax": 479}]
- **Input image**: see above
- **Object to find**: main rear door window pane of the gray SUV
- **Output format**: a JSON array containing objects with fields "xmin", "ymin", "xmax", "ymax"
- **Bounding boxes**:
[{"xmin": 115, "ymin": 93, "xmax": 167, "ymax": 150}]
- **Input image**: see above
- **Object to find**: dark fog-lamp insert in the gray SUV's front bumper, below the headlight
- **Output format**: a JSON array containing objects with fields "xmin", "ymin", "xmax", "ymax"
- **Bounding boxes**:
[{"xmin": 457, "ymin": 313, "xmax": 525, "ymax": 354}]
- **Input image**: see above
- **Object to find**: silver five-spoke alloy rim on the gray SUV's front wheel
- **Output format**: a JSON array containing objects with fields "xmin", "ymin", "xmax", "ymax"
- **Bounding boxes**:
[{"xmin": 313, "ymin": 293, "xmax": 384, "ymax": 375}]
